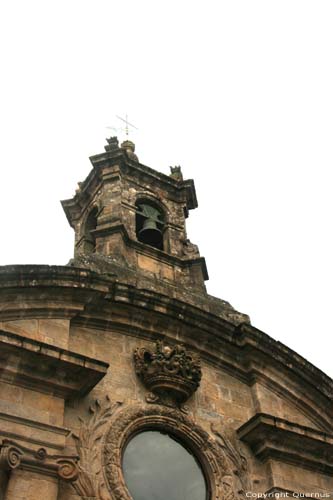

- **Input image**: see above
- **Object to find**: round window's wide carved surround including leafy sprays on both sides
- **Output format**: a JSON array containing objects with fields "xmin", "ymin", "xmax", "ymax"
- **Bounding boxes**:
[{"xmin": 72, "ymin": 397, "xmax": 247, "ymax": 500}]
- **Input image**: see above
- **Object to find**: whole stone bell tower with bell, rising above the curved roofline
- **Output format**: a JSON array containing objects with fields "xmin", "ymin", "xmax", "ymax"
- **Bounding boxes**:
[{"xmin": 62, "ymin": 137, "xmax": 208, "ymax": 291}]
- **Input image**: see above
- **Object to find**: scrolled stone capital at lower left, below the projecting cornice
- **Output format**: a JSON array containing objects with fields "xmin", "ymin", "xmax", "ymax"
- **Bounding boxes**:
[{"xmin": 0, "ymin": 439, "xmax": 78, "ymax": 482}]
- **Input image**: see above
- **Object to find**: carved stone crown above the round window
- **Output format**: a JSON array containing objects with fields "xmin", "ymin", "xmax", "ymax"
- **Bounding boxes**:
[{"xmin": 134, "ymin": 341, "xmax": 201, "ymax": 406}]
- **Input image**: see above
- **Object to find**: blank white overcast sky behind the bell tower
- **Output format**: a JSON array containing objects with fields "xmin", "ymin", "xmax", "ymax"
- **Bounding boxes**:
[{"xmin": 0, "ymin": 0, "xmax": 333, "ymax": 376}]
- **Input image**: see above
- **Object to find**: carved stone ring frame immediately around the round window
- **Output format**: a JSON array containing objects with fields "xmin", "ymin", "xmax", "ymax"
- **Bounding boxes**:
[{"xmin": 102, "ymin": 405, "xmax": 233, "ymax": 500}]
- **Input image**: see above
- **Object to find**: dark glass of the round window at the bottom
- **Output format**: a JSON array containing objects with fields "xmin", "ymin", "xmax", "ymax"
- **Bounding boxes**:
[{"xmin": 123, "ymin": 431, "xmax": 207, "ymax": 500}]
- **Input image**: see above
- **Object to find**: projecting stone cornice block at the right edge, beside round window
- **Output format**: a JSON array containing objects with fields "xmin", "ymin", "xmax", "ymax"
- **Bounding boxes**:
[{"xmin": 237, "ymin": 413, "xmax": 333, "ymax": 474}]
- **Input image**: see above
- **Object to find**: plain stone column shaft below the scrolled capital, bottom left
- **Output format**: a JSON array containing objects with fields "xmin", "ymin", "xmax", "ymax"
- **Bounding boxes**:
[{"xmin": 5, "ymin": 469, "xmax": 58, "ymax": 500}]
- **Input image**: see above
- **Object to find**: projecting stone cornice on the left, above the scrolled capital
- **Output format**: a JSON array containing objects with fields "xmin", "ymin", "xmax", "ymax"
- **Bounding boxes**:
[{"xmin": 0, "ymin": 330, "xmax": 108, "ymax": 399}]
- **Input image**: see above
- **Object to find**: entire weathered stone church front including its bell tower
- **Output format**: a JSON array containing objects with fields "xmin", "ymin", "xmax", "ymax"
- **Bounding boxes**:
[{"xmin": 0, "ymin": 138, "xmax": 333, "ymax": 500}]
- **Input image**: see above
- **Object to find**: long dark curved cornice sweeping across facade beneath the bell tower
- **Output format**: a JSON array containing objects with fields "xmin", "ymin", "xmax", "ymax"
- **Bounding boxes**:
[{"xmin": 0, "ymin": 266, "xmax": 333, "ymax": 431}]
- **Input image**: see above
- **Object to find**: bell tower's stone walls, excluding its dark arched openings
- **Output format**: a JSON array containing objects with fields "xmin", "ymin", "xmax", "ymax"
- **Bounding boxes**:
[{"xmin": 63, "ymin": 148, "xmax": 207, "ymax": 290}]
